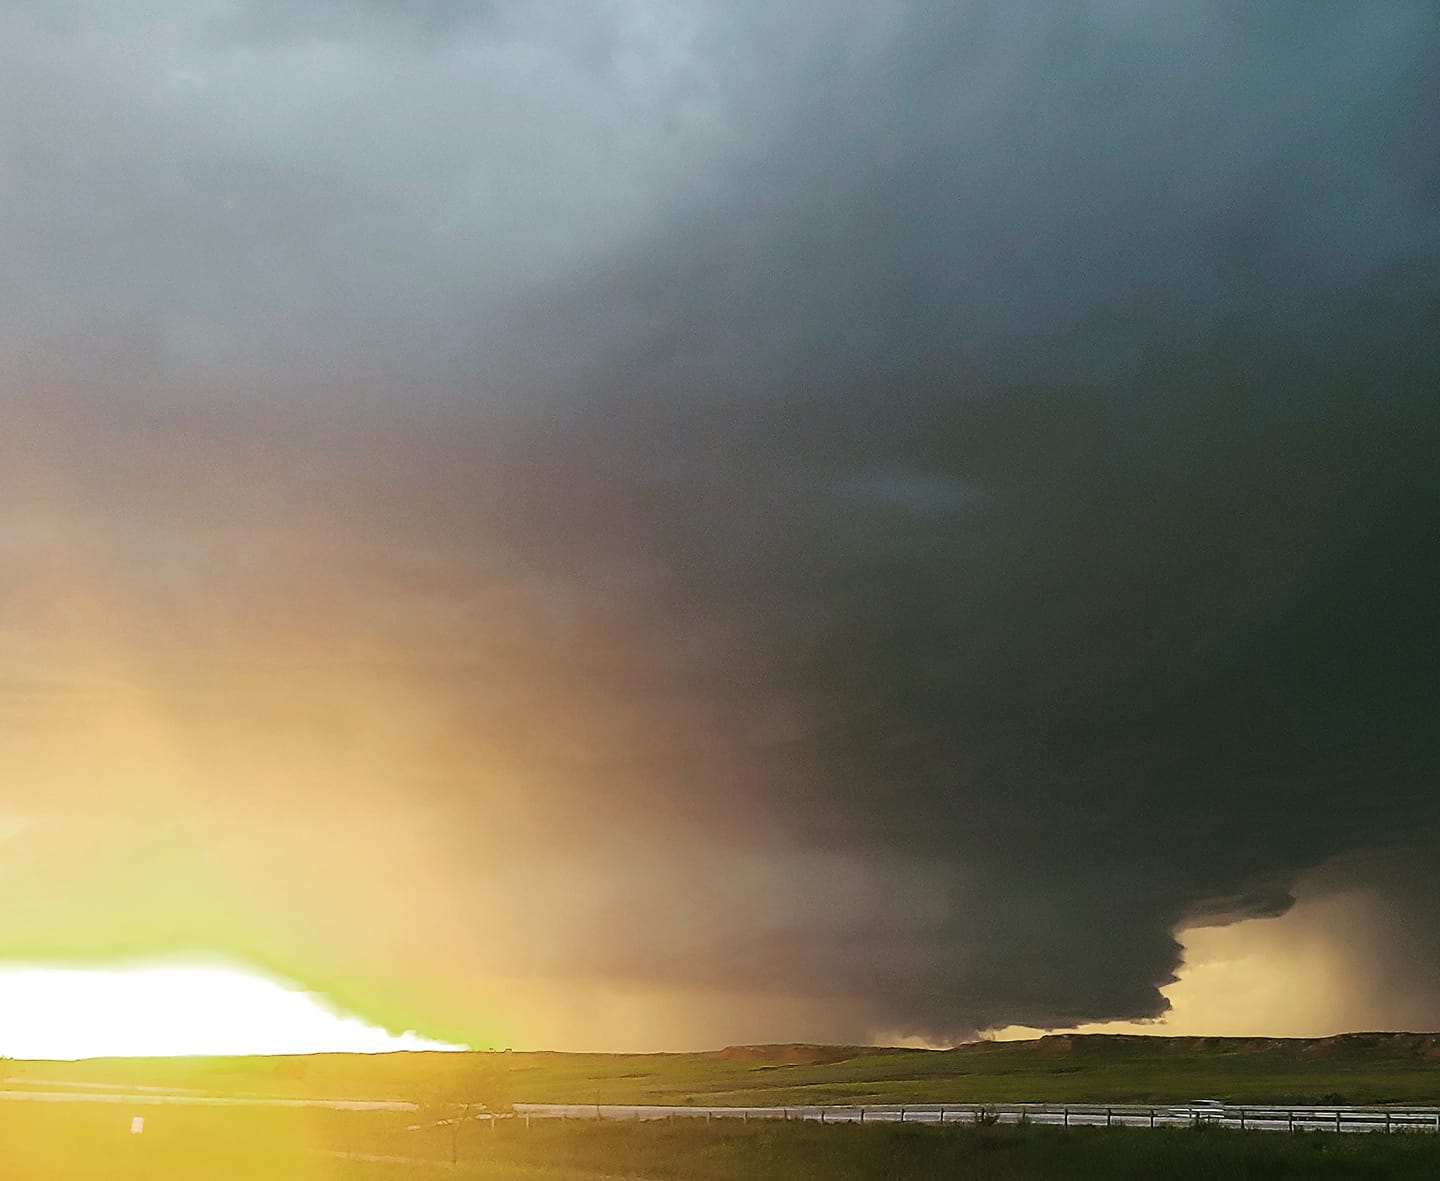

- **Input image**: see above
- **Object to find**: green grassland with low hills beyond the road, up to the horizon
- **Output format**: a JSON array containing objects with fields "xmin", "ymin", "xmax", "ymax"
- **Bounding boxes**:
[{"xmin": 11, "ymin": 1034, "xmax": 1440, "ymax": 1106}]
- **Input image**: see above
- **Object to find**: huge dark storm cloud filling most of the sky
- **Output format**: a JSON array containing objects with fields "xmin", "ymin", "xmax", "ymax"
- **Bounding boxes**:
[{"xmin": 8, "ymin": 3, "xmax": 1440, "ymax": 1040}]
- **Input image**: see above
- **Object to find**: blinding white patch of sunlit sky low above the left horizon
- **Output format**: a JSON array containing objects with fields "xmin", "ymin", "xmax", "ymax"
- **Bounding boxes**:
[{"xmin": 0, "ymin": 964, "xmax": 464, "ymax": 1059}]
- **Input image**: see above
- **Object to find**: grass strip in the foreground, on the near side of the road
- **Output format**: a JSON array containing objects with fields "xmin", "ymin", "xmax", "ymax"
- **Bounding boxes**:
[{"xmin": 0, "ymin": 1105, "xmax": 1440, "ymax": 1181}]
